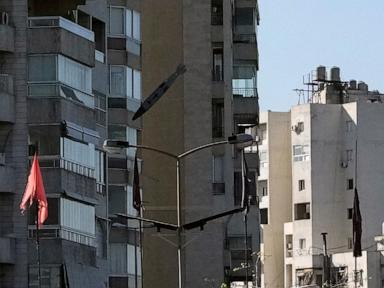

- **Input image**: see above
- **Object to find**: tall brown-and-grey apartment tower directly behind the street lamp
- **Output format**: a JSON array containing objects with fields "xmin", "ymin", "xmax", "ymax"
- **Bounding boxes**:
[{"xmin": 142, "ymin": 0, "xmax": 259, "ymax": 287}]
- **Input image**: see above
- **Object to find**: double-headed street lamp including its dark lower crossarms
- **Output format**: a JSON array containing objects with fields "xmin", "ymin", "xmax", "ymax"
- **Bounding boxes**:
[{"xmin": 103, "ymin": 134, "xmax": 253, "ymax": 288}]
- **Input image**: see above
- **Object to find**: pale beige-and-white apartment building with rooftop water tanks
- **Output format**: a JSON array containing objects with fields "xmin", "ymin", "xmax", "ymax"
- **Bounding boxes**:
[{"xmin": 258, "ymin": 67, "xmax": 384, "ymax": 287}]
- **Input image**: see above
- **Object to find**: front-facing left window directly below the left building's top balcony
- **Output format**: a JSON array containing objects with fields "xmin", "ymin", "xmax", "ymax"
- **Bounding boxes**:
[{"xmin": 28, "ymin": 55, "xmax": 56, "ymax": 82}]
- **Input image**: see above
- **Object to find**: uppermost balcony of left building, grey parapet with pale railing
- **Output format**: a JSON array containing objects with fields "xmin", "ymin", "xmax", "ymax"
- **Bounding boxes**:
[{"xmin": 28, "ymin": 16, "xmax": 95, "ymax": 67}]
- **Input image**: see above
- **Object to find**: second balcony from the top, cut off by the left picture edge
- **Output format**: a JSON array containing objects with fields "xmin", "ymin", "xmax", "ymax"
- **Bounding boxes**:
[{"xmin": 0, "ymin": 74, "xmax": 15, "ymax": 123}]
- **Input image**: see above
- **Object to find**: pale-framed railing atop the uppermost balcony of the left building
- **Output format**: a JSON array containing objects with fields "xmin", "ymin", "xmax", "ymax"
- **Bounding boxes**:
[{"xmin": 28, "ymin": 16, "xmax": 95, "ymax": 42}]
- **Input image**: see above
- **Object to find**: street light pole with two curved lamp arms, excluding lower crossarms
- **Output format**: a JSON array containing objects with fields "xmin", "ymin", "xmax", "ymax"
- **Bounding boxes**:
[{"xmin": 103, "ymin": 134, "xmax": 253, "ymax": 288}]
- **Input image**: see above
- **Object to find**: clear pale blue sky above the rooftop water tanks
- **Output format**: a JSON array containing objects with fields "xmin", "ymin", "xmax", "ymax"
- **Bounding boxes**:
[{"xmin": 258, "ymin": 0, "xmax": 384, "ymax": 111}]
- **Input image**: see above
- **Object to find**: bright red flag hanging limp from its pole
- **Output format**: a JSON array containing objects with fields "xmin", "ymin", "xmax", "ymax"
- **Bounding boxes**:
[{"xmin": 20, "ymin": 154, "xmax": 48, "ymax": 228}]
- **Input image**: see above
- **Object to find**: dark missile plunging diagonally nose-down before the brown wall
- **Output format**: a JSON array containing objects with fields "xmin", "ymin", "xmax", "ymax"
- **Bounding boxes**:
[{"xmin": 132, "ymin": 64, "xmax": 187, "ymax": 120}]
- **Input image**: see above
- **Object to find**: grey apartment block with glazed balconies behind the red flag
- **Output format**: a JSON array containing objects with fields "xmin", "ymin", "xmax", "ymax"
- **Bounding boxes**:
[{"xmin": 0, "ymin": 0, "xmax": 141, "ymax": 287}]
